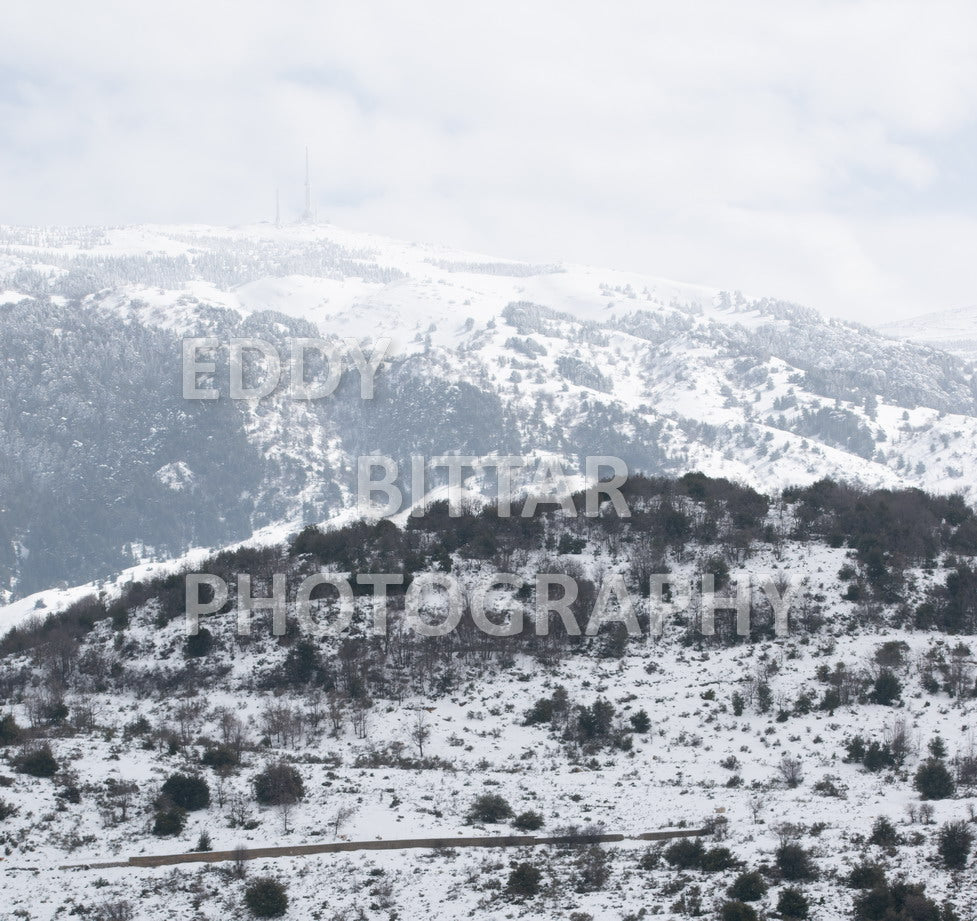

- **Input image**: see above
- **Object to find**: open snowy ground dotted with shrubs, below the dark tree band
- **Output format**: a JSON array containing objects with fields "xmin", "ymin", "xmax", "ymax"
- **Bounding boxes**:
[{"xmin": 0, "ymin": 528, "xmax": 977, "ymax": 919}]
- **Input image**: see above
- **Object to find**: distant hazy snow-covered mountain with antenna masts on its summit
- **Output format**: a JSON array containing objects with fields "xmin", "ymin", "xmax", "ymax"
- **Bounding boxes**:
[{"xmin": 0, "ymin": 224, "xmax": 977, "ymax": 597}]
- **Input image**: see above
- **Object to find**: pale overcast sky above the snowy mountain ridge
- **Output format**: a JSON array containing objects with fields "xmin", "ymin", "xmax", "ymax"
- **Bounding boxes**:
[{"xmin": 0, "ymin": 0, "xmax": 977, "ymax": 322}]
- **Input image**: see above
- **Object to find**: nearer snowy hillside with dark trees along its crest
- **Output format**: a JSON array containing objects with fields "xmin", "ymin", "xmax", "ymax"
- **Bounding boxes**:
[{"xmin": 0, "ymin": 474, "xmax": 977, "ymax": 921}]
